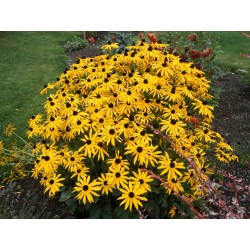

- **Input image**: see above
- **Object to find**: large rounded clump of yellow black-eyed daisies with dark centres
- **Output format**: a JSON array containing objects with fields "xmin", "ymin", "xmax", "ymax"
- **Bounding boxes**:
[{"xmin": 27, "ymin": 40, "xmax": 237, "ymax": 217}]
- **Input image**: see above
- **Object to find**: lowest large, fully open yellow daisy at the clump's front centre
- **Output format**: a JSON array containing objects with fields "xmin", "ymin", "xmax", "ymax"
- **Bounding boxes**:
[{"xmin": 118, "ymin": 182, "xmax": 148, "ymax": 211}]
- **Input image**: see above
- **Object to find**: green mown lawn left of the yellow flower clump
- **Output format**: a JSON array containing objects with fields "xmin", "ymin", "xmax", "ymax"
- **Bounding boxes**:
[{"xmin": 0, "ymin": 32, "xmax": 79, "ymax": 145}]
